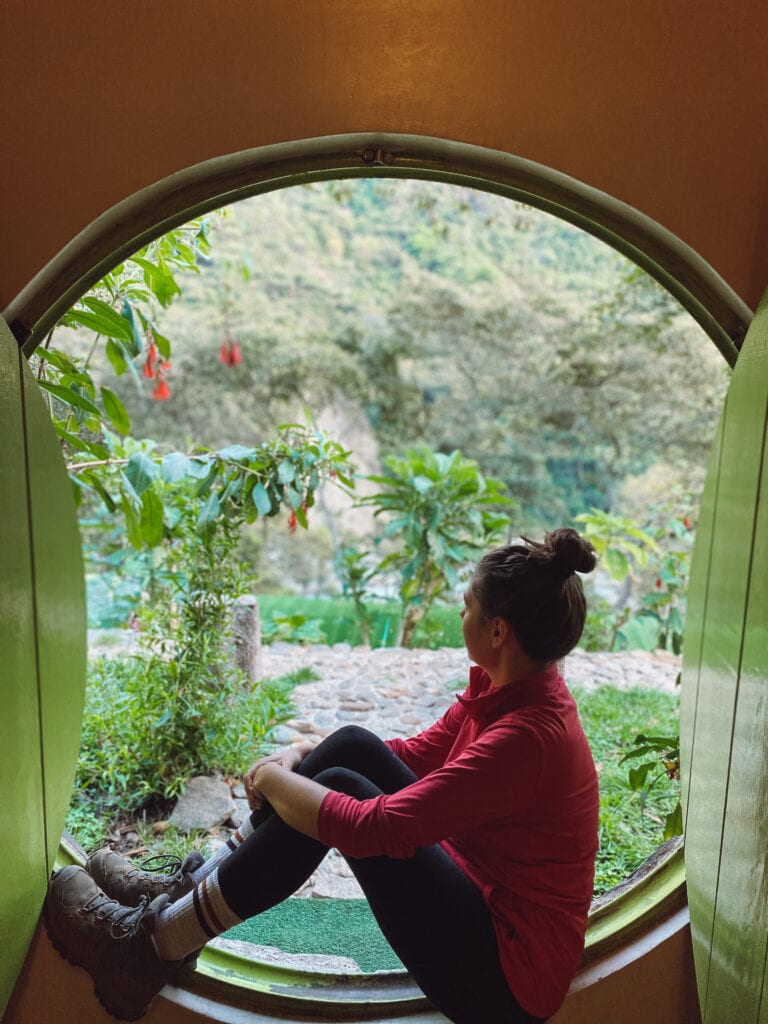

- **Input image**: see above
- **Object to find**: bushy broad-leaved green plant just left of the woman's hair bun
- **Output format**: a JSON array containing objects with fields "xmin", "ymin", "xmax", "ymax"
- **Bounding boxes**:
[{"xmin": 360, "ymin": 446, "xmax": 511, "ymax": 647}]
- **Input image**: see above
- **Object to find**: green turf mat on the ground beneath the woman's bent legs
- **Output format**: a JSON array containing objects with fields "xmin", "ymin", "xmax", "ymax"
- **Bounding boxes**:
[{"xmin": 225, "ymin": 898, "xmax": 402, "ymax": 974}]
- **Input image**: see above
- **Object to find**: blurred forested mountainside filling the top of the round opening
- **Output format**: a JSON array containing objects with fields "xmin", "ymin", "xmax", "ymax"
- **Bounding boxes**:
[{"xmin": 81, "ymin": 179, "xmax": 727, "ymax": 528}]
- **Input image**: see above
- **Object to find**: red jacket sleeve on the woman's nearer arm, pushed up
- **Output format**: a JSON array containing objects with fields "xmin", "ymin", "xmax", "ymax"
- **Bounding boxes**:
[{"xmin": 317, "ymin": 724, "xmax": 544, "ymax": 857}]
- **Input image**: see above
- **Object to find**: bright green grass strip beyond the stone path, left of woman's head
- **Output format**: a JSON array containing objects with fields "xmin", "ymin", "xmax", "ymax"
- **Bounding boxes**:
[{"xmin": 259, "ymin": 594, "xmax": 464, "ymax": 649}]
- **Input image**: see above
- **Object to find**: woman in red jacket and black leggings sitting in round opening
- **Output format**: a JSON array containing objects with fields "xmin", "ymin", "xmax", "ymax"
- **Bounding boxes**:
[{"xmin": 44, "ymin": 529, "xmax": 598, "ymax": 1024}]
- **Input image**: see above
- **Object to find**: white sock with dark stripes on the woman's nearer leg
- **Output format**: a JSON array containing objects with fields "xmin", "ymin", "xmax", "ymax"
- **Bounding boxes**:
[{"xmin": 155, "ymin": 869, "xmax": 243, "ymax": 961}]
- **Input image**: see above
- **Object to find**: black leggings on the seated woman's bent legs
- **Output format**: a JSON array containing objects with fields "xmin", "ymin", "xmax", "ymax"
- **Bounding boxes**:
[{"xmin": 219, "ymin": 726, "xmax": 543, "ymax": 1024}]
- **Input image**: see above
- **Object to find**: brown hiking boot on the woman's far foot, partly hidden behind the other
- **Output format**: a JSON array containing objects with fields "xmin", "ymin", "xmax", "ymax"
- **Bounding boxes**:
[{"xmin": 85, "ymin": 848, "xmax": 205, "ymax": 906}]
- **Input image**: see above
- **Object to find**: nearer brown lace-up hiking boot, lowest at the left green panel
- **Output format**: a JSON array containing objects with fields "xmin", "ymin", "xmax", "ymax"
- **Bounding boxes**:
[{"xmin": 43, "ymin": 864, "xmax": 185, "ymax": 1021}]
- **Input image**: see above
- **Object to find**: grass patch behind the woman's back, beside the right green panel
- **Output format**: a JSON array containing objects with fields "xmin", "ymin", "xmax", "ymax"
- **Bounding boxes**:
[{"xmin": 573, "ymin": 686, "xmax": 680, "ymax": 895}]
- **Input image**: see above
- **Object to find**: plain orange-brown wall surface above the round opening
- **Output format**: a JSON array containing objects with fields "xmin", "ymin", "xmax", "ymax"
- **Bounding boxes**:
[{"xmin": 0, "ymin": 0, "xmax": 768, "ymax": 308}]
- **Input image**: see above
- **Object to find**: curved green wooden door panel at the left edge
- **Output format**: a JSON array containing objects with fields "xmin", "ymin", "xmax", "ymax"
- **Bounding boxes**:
[{"xmin": 0, "ymin": 319, "xmax": 85, "ymax": 1015}]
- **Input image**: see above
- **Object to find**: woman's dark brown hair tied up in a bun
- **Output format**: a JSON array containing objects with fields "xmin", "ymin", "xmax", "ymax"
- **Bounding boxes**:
[{"xmin": 471, "ymin": 528, "xmax": 597, "ymax": 663}]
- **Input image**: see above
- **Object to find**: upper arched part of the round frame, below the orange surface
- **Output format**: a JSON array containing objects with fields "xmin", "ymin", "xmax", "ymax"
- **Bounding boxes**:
[{"xmin": 2, "ymin": 133, "xmax": 753, "ymax": 366}]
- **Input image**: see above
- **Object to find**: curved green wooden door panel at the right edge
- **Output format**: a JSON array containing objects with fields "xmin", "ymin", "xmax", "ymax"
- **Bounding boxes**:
[{"xmin": 681, "ymin": 290, "xmax": 768, "ymax": 1024}]
